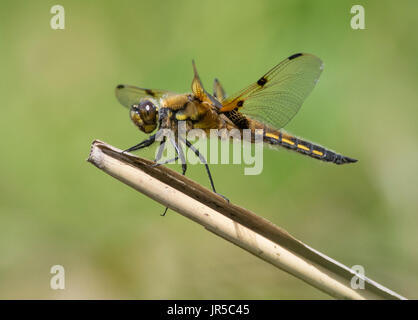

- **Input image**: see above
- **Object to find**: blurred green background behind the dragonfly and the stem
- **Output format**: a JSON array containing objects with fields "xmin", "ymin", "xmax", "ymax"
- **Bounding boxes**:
[{"xmin": 0, "ymin": 0, "xmax": 418, "ymax": 299}]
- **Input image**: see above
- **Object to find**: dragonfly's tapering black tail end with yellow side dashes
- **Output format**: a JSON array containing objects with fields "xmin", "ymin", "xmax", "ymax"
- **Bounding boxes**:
[{"xmin": 264, "ymin": 131, "xmax": 357, "ymax": 164}]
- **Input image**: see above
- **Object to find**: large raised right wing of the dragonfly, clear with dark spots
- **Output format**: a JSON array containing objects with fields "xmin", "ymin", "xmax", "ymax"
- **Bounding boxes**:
[{"xmin": 220, "ymin": 53, "xmax": 323, "ymax": 129}]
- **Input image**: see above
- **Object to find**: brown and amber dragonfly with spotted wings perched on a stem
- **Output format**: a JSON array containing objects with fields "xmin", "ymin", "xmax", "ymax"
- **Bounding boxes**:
[{"xmin": 115, "ymin": 53, "xmax": 357, "ymax": 198}]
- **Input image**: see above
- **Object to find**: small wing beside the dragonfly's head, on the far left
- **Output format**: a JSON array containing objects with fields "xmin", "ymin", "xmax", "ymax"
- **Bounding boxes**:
[{"xmin": 115, "ymin": 84, "xmax": 174, "ymax": 108}]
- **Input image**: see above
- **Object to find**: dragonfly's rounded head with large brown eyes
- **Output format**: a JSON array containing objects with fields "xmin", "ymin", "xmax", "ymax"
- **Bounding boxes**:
[{"xmin": 130, "ymin": 100, "xmax": 158, "ymax": 133}]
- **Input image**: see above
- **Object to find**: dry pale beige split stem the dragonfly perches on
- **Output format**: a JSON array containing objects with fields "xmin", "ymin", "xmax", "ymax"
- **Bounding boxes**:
[{"xmin": 88, "ymin": 140, "xmax": 405, "ymax": 299}]
